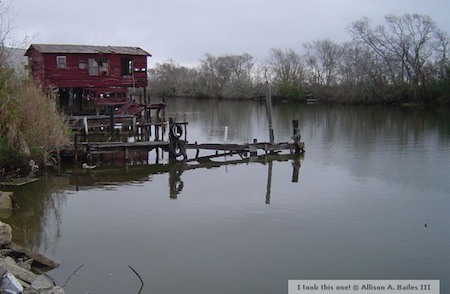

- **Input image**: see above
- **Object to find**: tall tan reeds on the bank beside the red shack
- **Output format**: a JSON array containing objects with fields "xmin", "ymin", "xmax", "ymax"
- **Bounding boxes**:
[{"xmin": 0, "ymin": 68, "xmax": 70, "ymax": 170}]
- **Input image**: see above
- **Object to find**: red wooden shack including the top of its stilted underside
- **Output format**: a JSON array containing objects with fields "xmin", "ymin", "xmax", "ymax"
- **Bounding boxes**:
[{"xmin": 25, "ymin": 44, "xmax": 151, "ymax": 113}]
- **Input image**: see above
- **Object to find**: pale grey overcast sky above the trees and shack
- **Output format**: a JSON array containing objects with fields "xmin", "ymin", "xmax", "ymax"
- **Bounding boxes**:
[{"xmin": 8, "ymin": 0, "xmax": 450, "ymax": 67}]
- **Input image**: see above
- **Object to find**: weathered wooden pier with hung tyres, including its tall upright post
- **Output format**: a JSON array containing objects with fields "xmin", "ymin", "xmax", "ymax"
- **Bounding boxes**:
[{"xmin": 58, "ymin": 88, "xmax": 305, "ymax": 164}]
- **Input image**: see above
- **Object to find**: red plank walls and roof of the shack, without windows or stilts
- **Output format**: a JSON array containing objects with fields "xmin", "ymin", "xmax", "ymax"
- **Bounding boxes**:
[{"xmin": 26, "ymin": 44, "xmax": 150, "ymax": 88}]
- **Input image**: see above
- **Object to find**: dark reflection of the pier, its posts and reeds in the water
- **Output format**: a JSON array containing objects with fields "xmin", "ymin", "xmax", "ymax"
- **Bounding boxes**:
[{"xmin": 0, "ymin": 154, "xmax": 303, "ymax": 251}]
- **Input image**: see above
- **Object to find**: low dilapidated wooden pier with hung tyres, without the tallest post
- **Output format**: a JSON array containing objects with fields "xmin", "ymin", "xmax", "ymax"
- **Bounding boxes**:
[{"xmin": 58, "ymin": 116, "xmax": 305, "ymax": 164}]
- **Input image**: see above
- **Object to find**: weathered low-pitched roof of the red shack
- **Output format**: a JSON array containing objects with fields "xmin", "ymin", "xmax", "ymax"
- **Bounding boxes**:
[{"xmin": 25, "ymin": 44, "xmax": 152, "ymax": 56}]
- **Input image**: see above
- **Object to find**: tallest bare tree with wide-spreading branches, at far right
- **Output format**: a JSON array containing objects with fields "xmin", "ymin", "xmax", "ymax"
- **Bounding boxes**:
[{"xmin": 350, "ymin": 14, "xmax": 448, "ymax": 99}]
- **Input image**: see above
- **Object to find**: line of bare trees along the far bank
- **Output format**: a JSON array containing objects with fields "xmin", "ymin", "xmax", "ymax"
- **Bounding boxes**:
[{"xmin": 149, "ymin": 14, "xmax": 450, "ymax": 104}]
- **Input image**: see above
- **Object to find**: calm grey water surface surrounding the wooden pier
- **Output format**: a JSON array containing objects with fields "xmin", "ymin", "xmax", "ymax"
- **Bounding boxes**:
[{"xmin": 2, "ymin": 99, "xmax": 450, "ymax": 293}]
